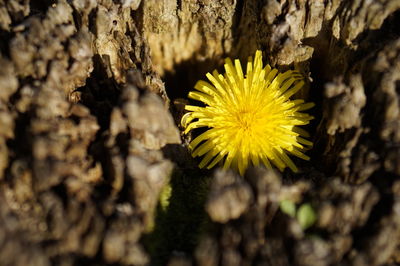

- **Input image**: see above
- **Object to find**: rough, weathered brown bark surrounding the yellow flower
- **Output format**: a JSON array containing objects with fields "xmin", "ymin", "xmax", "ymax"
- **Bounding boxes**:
[{"xmin": 0, "ymin": 0, "xmax": 400, "ymax": 266}]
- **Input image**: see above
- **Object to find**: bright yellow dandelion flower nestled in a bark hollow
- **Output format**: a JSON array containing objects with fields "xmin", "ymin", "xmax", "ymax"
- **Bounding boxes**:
[{"xmin": 181, "ymin": 51, "xmax": 314, "ymax": 175}]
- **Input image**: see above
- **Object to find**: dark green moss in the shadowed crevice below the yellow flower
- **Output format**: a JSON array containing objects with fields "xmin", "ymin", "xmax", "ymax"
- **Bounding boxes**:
[{"xmin": 143, "ymin": 169, "xmax": 210, "ymax": 265}]
